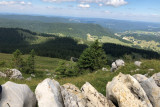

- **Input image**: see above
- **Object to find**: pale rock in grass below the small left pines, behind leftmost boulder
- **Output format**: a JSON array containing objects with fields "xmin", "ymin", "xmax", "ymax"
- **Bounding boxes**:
[{"xmin": 6, "ymin": 69, "xmax": 24, "ymax": 79}]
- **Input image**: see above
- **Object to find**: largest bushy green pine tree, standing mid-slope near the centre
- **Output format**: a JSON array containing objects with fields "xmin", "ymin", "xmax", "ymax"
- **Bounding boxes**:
[{"xmin": 78, "ymin": 40, "xmax": 107, "ymax": 72}]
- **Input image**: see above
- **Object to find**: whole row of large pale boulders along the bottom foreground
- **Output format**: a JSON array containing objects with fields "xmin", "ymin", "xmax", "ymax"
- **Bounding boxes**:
[{"xmin": 0, "ymin": 73, "xmax": 160, "ymax": 107}]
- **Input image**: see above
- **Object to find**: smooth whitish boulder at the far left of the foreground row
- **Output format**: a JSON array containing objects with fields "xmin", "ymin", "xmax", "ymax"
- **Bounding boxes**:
[{"xmin": 0, "ymin": 81, "xmax": 36, "ymax": 107}]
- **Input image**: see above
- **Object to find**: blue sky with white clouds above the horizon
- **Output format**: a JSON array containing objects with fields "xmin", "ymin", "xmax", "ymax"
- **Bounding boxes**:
[{"xmin": 0, "ymin": 0, "xmax": 160, "ymax": 22}]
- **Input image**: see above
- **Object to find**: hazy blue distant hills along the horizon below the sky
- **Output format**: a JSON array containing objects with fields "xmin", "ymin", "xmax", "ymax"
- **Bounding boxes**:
[{"xmin": 0, "ymin": 15, "xmax": 160, "ymax": 32}]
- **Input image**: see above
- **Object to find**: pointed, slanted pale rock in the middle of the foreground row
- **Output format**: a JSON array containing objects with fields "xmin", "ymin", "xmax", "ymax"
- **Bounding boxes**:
[{"xmin": 81, "ymin": 82, "xmax": 115, "ymax": 107}]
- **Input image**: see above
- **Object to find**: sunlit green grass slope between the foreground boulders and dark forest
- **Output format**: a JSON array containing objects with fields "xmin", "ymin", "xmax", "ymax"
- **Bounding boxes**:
[{"xmin": 0, "ymin": 54, "xmax": 160, "ymax": 95}]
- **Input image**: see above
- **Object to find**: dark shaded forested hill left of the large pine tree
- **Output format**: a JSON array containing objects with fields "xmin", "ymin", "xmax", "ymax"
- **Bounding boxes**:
[{"xmin": 0, "ymin": 28, "xmax": 87, "ymax": 59}]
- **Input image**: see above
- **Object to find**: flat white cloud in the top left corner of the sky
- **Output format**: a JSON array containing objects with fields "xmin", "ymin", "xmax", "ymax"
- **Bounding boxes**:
[{"xmin": 0, "ymin": 1, "xmax": 32, "ymax": 5}]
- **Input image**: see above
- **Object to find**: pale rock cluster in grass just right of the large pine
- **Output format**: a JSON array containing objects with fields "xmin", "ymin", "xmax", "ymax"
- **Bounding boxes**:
[{"xmin": 111, "ymin": 59, "xmax": 125, "ymax": 72}]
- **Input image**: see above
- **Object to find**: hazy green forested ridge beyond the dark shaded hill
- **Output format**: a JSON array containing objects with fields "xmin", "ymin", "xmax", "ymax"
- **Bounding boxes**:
[{"xmin": 0, "ymin": 18, "xmax": 113, "ymax": 39}]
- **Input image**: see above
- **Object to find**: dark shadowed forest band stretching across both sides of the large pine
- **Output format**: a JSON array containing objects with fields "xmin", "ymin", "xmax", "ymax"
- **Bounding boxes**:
[{"xmin": 0, "ymin": 28, "xmax": 160, "ymax": 60}]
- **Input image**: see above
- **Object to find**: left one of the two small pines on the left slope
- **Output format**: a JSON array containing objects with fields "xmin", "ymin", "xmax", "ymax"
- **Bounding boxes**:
[{"xmin": 12, "ymin": 49, "xmax": 24, "ymax": 70}]
